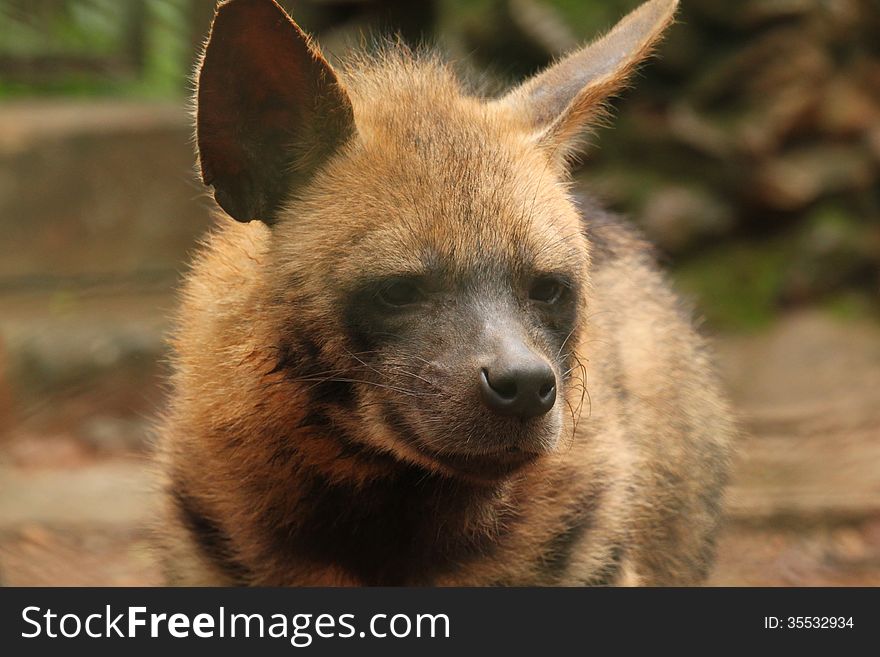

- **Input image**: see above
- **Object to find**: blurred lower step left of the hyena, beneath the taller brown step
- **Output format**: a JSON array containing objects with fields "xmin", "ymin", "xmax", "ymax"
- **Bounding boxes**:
[{"xmin": 0, "ymin": 286, "xmax": 174, "ymax": 451}]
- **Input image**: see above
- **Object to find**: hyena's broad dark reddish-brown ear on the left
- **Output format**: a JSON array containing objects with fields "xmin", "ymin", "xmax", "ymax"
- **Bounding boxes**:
[{"xmin": 196, "ymin": 0, "xmax": 354, "ymax": 224}]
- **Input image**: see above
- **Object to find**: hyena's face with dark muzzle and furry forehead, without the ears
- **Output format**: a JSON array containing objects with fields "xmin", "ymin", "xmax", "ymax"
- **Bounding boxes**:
[{"xmin": 275, "ymin": 105, "xmax": 588, "ymax": 476}]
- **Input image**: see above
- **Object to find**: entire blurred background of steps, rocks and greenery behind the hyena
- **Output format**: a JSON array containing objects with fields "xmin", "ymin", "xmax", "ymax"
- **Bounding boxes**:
[{"xmin": 0, "ymin": 0, "xmax": 880, "ymax": 585}]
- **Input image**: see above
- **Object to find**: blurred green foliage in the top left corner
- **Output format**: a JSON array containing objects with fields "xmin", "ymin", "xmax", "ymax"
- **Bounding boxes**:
[{"xmin": 0, "ymin": 0, "xmax": 192, "ymax": 98}]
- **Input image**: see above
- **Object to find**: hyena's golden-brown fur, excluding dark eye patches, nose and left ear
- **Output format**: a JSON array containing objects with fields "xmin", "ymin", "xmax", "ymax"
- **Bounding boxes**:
[{"xmin": 155, "ymin": 0, "xmax": 733, "ymax": 585}]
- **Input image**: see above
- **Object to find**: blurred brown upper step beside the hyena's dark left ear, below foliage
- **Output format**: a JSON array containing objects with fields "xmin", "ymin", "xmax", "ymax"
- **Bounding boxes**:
[{"xmin": 0, "ymin": 100, "xmax": 211, "ymax": 291}]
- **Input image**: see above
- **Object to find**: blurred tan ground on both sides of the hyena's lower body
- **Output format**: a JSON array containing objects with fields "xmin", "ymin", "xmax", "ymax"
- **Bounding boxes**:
[{"xmin": 0, "ymin": 312, "xmax": 880, "ymax": 586}]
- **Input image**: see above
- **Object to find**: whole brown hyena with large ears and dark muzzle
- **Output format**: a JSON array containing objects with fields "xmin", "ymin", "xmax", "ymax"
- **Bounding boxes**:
[{"xmin": 159, "ymin": 0, "xmax": 734, "ymax": 586}]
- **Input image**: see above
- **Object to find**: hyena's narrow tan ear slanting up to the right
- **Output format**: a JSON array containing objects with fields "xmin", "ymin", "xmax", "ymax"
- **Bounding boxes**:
[{"xmin": 498, "ymin": 0, "xmax": 678, "ymax": 159}]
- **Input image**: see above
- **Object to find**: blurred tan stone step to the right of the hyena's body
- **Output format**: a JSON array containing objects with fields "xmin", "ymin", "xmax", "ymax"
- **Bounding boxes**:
[{"xmin": 718, "ymin": 311, "xmax": 880, "ymax": 520}]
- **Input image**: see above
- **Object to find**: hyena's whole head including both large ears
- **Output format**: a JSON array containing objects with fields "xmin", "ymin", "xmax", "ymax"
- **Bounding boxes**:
[{"xmin": 197, "ymin": 0, "xmax": 677, "ymax": 482}]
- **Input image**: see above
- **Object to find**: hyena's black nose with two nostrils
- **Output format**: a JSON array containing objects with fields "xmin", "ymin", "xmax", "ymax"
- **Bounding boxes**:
[{"xmin": 480, "ymin": 356, "xmax": 556, "ymax": 418}]
